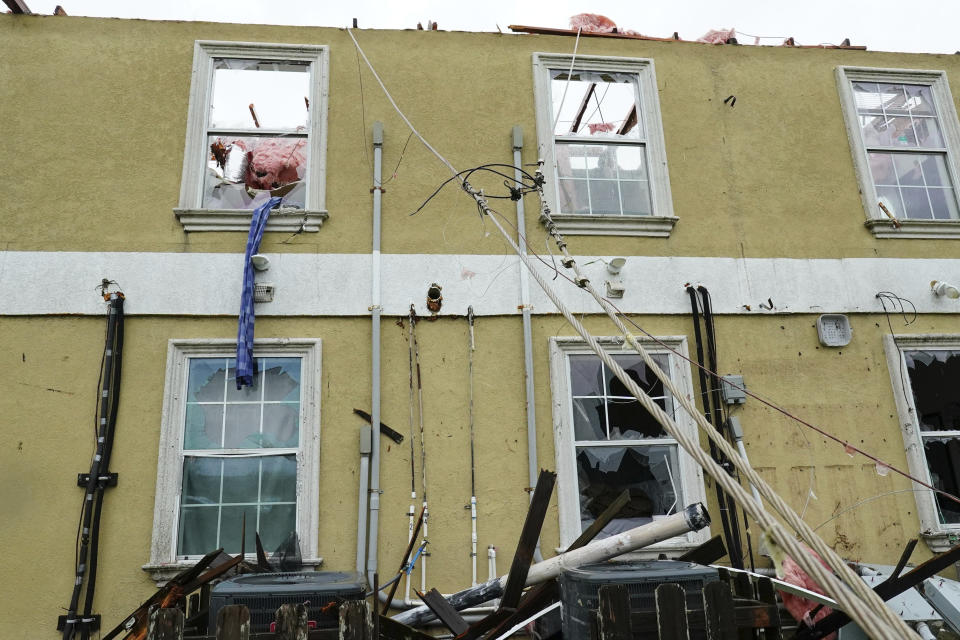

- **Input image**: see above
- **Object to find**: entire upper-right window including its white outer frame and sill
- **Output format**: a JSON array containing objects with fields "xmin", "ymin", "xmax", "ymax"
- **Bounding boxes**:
[{"xmin": 840, "ymin": 67, "xmax": 960, "ymax": 237}]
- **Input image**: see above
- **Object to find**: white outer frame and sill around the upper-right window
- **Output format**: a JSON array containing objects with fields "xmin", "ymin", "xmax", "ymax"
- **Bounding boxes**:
[{"xmin": 837, "ymin": 66, "xmax": 960, "ymax": 238}]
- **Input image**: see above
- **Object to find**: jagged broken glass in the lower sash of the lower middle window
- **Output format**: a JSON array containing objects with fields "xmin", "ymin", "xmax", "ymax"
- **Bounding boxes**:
[{"xmin": 577, "ymin": 444, "xmax": 683, "ymax": 538}]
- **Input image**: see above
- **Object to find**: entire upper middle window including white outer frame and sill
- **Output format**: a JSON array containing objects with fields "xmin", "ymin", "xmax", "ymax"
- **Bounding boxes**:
[{"xmin": 534, "ymin": 53, "xmax": 676, "ymax": 236}]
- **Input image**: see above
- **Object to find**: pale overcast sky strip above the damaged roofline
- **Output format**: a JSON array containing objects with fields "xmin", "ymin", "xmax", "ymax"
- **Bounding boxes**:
[{"xmin": 26, "ymin": 0, "xmax": 960, "ymax": 53}]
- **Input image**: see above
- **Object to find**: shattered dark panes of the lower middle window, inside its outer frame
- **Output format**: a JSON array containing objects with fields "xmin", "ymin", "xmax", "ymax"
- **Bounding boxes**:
[{"xmin": 569, "ymin": 354, "xmax": 683, "ymax": 537}]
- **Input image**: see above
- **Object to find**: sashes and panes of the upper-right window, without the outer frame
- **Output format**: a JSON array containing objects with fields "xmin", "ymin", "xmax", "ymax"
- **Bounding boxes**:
[{"xmin": 853, "ymin": 82, "xmax": 958, "ymax": 220}]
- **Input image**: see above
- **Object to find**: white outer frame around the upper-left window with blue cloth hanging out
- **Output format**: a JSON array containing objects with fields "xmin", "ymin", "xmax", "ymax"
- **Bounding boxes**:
[{"xmin": 174, "ymin": 40, "xmax": 330, "ymax": 232}]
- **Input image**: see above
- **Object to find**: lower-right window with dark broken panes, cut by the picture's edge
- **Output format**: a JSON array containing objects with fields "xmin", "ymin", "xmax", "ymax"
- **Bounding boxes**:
[{"xmin": 885, "ymin": 335, "xmax": 960, "ymax": 551}]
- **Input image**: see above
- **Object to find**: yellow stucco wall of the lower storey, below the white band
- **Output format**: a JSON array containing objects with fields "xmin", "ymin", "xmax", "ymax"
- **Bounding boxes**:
[{"xmin": 0, "ymin": 315, "xmax": 956, "ymax": 637}]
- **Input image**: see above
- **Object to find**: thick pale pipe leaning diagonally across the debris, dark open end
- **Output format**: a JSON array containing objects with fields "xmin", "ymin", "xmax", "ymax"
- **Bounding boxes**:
[{"xmin": 393, "ymin": 503, "xmax": 710, "ymax": 627}]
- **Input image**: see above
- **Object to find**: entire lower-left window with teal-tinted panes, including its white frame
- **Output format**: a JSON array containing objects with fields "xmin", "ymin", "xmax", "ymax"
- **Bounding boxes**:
[{"xmin": 144, "ymin": 340, "xmax": 319, "ymax": 584}]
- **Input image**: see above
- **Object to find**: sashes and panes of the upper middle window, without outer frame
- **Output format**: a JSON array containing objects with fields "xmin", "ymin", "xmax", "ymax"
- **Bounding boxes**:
[{"xmin": 551, "ymin": 69, "xmax": 653, "ymax": 216}]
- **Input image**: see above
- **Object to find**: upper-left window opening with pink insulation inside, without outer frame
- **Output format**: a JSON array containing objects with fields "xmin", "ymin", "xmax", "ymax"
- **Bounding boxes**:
[{"xmin": 203, "ymin": 58, "xmax": 311, "ymax": 209}]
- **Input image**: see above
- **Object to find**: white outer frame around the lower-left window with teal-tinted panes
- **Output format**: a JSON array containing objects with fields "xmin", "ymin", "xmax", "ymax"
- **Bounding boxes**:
[{"xmin": 143, "ymin": 338, "xmax": 323, "ymax": 583}]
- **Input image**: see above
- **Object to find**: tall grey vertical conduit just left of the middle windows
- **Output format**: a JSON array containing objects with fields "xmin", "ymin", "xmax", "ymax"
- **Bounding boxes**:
[{"xmin": 512, "ymin": 125, "xmax": 543, "ymax": 562}]
